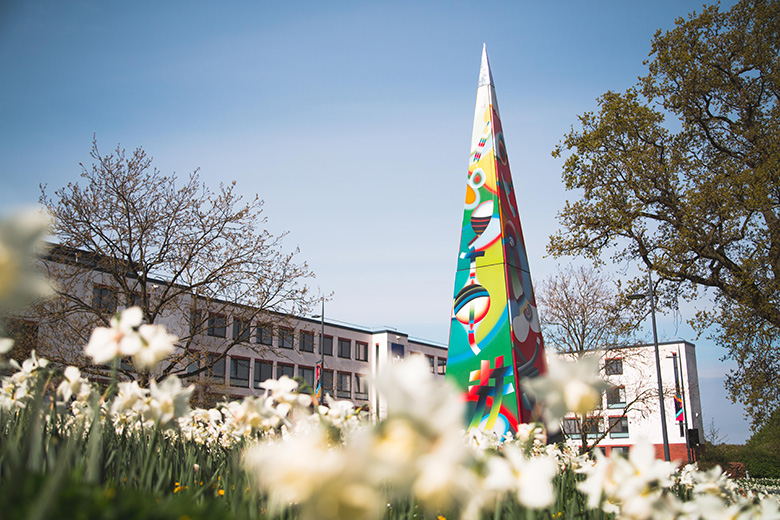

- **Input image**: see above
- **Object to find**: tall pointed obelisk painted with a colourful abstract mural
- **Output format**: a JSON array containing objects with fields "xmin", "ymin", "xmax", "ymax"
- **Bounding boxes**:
[{"xmin": 446, "ymin": 47, "xmax": 547, "ymax": 434}]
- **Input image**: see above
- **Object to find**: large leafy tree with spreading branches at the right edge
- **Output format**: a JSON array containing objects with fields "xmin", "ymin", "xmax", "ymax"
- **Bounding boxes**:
[{"xmin": 548, "ymin": 0, "xmax": 780, "ymax": 426}]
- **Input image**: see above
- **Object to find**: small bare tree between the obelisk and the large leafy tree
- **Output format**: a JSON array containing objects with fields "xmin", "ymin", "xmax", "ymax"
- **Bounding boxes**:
[{"xmin": 536, "ymin": 266, "xmax": 658, "ymax": 453}]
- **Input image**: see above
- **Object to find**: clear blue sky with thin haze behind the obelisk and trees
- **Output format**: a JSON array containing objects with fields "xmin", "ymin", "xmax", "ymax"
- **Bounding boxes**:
[{"xmin": 0, "ymin": 0, "xmax": 748, "ymax": 442}]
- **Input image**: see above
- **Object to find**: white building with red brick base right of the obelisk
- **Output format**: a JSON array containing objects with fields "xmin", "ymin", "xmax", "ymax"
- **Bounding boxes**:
[{"xmin": 563, "ymin": 341, "xmax": 703, "ymax": 462}]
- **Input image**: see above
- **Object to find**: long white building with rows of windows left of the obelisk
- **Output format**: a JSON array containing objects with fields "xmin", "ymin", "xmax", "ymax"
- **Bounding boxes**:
[{"xmin": 10, "ymin": 246, "xmax": 447, "ymax": 413}]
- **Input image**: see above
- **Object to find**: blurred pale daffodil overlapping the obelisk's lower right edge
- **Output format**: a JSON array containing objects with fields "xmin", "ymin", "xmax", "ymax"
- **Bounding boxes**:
[{"xmin": 522, "ymin": 356, "xmax": 609, "ymax": 432}]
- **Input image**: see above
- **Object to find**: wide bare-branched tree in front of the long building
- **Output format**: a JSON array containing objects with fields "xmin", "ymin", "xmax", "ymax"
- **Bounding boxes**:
[{"xmin": 36, "ymin": 140, "xmax": 316, "ymax": 384}]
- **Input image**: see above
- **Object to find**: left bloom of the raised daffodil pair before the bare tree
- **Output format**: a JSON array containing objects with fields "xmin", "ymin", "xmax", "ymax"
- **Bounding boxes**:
[{"xmin": 84, "ymin": 307, "xmax": 143, "ymax": 363}]
